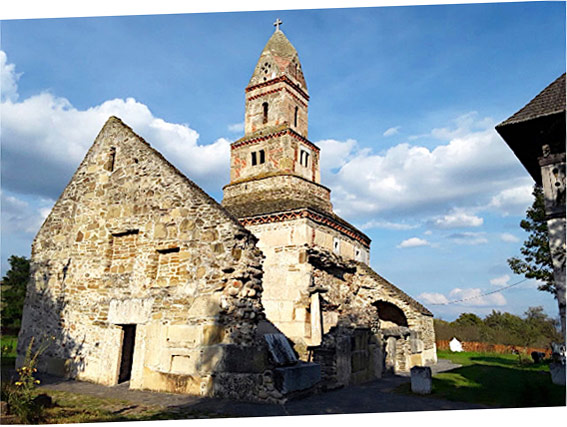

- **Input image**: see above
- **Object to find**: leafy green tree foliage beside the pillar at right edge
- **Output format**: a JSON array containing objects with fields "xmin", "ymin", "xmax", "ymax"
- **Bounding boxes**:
[{"xmin": 508, "ymin": 185, "xmax": 557, "ymax": 298}]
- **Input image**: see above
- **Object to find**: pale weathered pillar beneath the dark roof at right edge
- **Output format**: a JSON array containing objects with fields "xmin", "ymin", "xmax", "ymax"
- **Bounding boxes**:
[{"xmin": 539, "ymin": 149, "xmax": 566, "ymax": 342}]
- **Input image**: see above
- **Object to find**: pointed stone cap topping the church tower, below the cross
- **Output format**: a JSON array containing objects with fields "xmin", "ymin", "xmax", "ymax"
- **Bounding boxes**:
[{"xmin": 248, "ymin": 29, "xmax": 307, "ymax": 91}]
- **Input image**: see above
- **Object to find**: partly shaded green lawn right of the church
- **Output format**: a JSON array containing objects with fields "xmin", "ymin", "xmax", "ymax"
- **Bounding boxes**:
[{"xmin": 420, "ymin": 351, "xmax": 565, "ymax": 408}]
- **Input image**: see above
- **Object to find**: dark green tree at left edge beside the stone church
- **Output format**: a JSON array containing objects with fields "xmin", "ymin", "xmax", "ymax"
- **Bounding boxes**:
[{"xmin": 1, "ymin": 255, "xmax": 30, "ymax": 329}]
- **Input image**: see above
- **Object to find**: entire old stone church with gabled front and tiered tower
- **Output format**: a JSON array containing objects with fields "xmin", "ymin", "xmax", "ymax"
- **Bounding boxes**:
[{"xmin": 18, "ymin": 26, "xmax": 436, "ymax": 401}]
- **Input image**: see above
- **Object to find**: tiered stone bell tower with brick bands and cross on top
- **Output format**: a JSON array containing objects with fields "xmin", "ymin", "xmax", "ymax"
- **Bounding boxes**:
[{"xmin": 223, "ymin": 19, "xmax": 332, "ymax": 214}]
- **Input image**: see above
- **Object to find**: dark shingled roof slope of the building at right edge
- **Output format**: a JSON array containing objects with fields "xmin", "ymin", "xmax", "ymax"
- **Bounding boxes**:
[{"xmin": 497, "ymin": 73, "xmax": 565, "ymax": 128}]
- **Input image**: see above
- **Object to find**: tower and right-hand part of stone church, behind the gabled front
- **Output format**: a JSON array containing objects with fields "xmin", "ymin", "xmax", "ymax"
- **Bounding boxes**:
[{"xmin": 222, "ymin": 28, "xmax": 436, "ymax": 387}]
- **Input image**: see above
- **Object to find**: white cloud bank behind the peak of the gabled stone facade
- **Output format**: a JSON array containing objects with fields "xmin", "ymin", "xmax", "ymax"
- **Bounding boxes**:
[{"xmin": 0, "ymin": 49, "xmax": 230, "ymax": 198}]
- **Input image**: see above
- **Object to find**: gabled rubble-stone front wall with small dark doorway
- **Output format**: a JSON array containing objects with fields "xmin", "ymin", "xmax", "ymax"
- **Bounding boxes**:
[{"xmin": 18, "ymin": 118, "xmax": 284, "ymax": 399}]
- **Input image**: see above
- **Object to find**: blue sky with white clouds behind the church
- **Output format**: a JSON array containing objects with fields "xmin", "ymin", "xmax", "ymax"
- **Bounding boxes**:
[{"xmin": 0, "ymin": 2, "xmax": 565, "ymax": 319}]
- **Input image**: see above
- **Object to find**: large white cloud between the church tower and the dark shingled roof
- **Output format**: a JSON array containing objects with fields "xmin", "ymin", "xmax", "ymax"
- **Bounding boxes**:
[{"xmin": 316, "ymin": 113, "xmax": 529, "ymax": 222}]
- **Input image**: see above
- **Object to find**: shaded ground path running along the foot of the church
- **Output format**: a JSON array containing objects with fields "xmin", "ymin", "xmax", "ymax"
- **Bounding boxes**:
[{"xmin": 26, "ymin": 366, "xmax": 486, "ymax": 417}]
